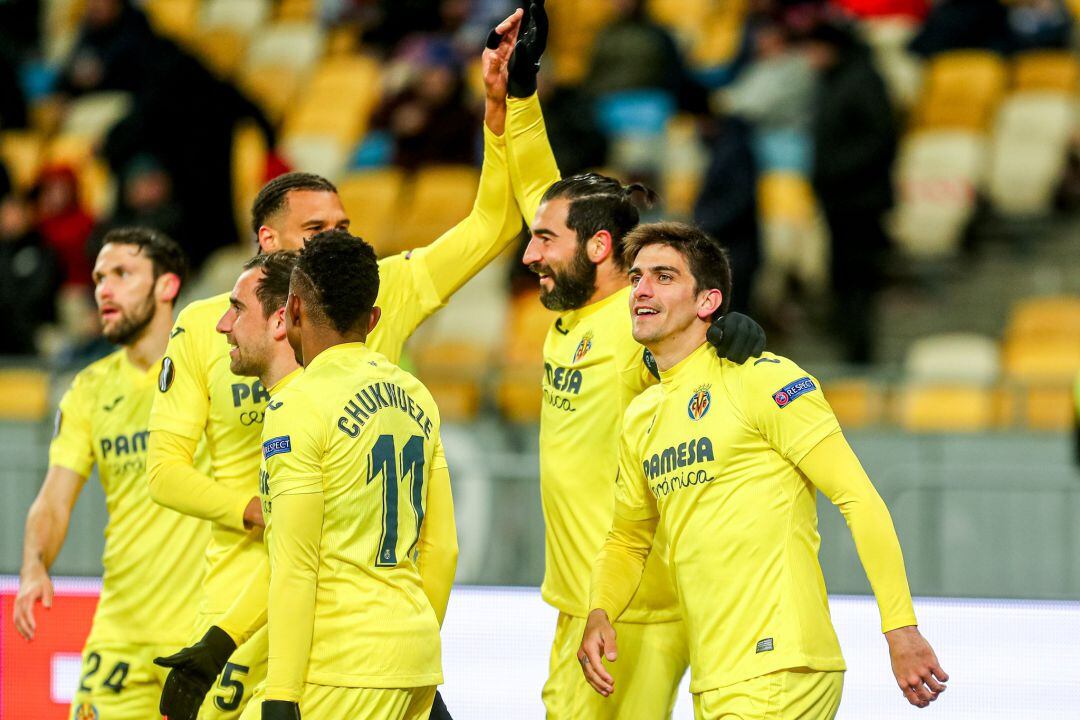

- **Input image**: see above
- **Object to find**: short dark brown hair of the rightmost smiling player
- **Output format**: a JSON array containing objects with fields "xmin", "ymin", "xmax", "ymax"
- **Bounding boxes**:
[{"xmin": 623, "ymin": 222, "xmax": 731, "ymax": 317}]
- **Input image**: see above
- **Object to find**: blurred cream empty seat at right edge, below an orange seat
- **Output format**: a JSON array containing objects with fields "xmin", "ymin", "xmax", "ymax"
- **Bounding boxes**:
[{"xmin": 988, "ymin": 91, "xmax": 1077, "ymax": 216}]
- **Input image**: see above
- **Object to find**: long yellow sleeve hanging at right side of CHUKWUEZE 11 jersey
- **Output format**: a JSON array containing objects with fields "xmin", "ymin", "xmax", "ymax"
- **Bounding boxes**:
[{"xmin": 417, "ymin": 435, "xmax": 458, "ymax": 625}]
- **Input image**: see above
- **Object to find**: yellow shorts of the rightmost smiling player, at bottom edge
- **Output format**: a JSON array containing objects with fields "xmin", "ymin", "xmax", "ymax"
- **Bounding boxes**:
[{"xmin": 693, "ymin": 667, "xmax": 843, "ymax": 720}]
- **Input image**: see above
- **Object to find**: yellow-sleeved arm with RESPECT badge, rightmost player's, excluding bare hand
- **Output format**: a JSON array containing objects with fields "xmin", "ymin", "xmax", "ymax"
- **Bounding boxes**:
[{"xmin": 743, "ymin": 358, "xmax": 916, "ymax": 631}]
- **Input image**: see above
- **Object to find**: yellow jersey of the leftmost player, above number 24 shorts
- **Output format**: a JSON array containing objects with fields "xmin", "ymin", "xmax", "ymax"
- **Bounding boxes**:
[{"xmin": 49, "ymin": 350, "xmax": 208, "ymax": 646}]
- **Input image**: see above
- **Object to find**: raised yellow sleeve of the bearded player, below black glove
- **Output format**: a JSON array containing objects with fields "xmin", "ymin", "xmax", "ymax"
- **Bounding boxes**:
[{"xmin": 507, "ymin": 93, "xmax": 559, "ymax": 225}]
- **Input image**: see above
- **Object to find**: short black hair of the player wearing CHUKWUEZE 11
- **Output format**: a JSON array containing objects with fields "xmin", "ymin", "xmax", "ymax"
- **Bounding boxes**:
[{"xmin": 293, "ymin": 229, "xmax": 379, "ymax": 332}]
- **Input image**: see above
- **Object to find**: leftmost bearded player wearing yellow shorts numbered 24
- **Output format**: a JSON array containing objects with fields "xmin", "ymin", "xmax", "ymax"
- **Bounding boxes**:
[{"xmin": 14, "ymin": 229, "xmax": 208, "ymax": 720}]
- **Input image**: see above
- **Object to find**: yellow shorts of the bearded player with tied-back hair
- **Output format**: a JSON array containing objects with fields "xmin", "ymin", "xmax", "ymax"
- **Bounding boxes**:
[{"xmin": 543, "ymin": 613, "xmax": 689, "ymax": 720}]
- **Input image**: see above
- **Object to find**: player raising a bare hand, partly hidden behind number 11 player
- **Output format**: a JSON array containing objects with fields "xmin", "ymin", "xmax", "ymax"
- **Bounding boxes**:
[{"xmin": 142, "ymin": 13, "xmax": 521, "ymax": 718}]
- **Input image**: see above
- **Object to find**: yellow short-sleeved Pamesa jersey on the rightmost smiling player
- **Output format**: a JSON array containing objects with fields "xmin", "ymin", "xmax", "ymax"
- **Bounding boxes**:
[{"xmin": 616, "ymin": 343, "xmax": 845, "ymax": 693}]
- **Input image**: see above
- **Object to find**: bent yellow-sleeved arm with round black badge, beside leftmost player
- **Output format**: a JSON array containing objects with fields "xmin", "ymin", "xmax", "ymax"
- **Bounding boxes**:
[{"xmin": 146, "ymin": 313, "xmax": 252, "ymax": 530}]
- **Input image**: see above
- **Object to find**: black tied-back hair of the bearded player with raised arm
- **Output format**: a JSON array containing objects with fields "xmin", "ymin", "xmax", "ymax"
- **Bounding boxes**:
[{"xmin": 541, "ymin": 173, "xmax": 658, "ymax": 268}]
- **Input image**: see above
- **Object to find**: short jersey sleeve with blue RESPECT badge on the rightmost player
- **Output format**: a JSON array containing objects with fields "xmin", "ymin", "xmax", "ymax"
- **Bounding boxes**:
[{"xmin": 738, "ymin": 353, "xmax": 840, "ymax": 465}]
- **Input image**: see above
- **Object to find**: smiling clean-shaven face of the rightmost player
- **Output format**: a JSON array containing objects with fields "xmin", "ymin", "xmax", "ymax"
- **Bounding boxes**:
[{"xmin": 629, "ymin": 244, "xmax": 707, "ymax": 347}]
